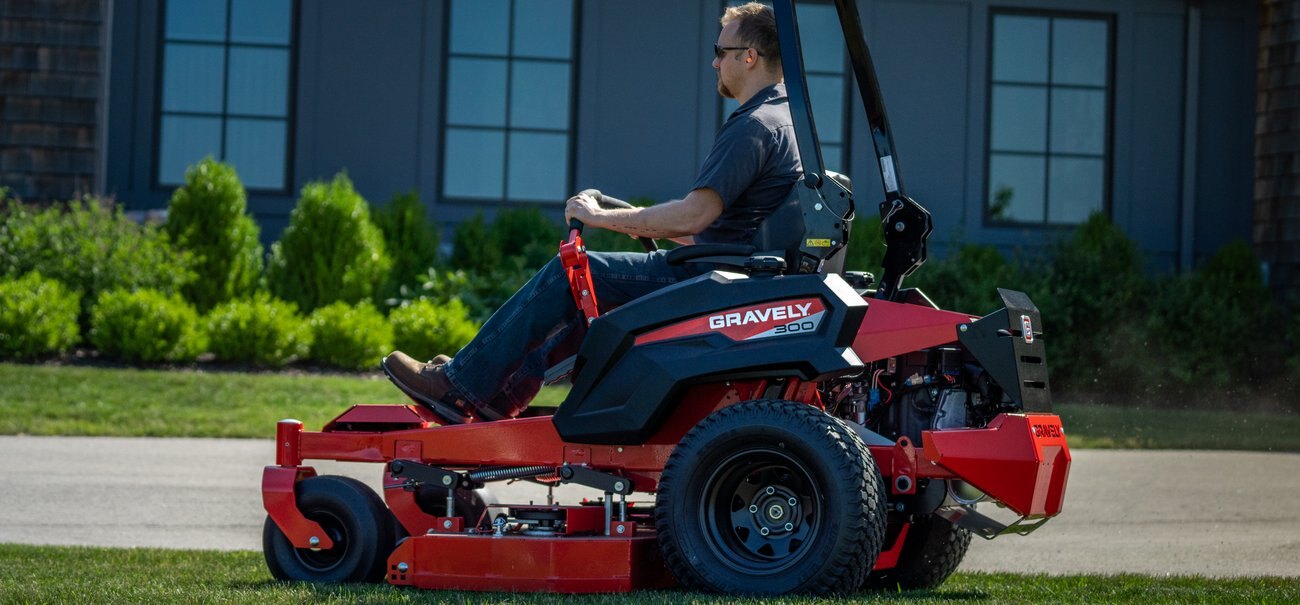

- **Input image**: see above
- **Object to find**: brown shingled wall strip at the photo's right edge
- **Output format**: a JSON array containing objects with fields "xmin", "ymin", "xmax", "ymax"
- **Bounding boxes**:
[{"xmin": 1255, "ymin": 0, "xmax": 1300, "ymax": 301}]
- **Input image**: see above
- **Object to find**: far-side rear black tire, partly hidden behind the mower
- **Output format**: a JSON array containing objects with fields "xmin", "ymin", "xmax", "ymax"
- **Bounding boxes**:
[{"xmin": 863, "ymin": 515, "xmax": 971, "ymax": 591}]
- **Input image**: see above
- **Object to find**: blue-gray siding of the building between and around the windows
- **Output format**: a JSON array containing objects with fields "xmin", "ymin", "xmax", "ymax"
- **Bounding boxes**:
[{"xmin": 98, "ymin": 0, "xmax": 1256, "ymax": 267}]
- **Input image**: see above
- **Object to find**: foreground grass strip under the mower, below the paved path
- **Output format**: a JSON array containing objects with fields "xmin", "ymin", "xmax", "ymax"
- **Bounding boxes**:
[{"xmin": 0, "ymin": 545, "xmax": 1300, "ymax": 605}]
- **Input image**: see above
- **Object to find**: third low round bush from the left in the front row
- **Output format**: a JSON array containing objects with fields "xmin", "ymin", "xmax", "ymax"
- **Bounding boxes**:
[{"xmin": 207, "ymin": 293, "xmax": 312, "ymax": 367}]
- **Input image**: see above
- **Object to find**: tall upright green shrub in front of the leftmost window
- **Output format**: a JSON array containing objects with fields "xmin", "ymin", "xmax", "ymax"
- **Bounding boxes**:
[{"xmin": 166, "ymin": 157, "xmax": 263, "ymax": 311}]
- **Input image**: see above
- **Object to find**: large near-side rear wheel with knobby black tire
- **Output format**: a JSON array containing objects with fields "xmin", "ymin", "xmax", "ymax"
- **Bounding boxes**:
[{"xmin": 654, "ymin": 399, "xmax": 885, "ymax": 595}]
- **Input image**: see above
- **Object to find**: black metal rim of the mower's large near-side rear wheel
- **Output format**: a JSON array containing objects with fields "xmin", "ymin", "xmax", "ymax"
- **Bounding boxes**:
[{"xmin": 698, "ymin": 446, "xmax": 823, "ymax": 575}]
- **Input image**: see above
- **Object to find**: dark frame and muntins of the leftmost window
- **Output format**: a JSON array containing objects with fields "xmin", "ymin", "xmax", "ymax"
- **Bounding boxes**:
[{"xmin": 150, "ymin": 0, "xmax": 302, "ymax": 195}]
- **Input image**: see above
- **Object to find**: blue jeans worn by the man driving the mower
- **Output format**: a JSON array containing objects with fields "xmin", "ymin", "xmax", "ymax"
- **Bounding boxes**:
[{"xmin": 445, "ymin": 250, "xmax": 705, "ymax": 414}]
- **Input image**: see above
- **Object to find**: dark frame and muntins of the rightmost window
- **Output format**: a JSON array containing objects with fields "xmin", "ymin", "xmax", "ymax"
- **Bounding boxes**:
[{"xmin": 979, "ymin": 7, "xmax": 1118, "ymax": 230}]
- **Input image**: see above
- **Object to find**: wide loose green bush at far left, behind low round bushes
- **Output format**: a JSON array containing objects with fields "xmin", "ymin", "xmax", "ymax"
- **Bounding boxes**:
[{"xmin": 0, "ymin": 199, "xmax": 194, "ymax": 330}]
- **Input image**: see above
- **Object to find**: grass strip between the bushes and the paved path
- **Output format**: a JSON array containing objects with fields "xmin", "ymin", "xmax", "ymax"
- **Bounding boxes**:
[{"xmin": 0, "ymin": 363, "xmax": 1300, "ymax": 451}]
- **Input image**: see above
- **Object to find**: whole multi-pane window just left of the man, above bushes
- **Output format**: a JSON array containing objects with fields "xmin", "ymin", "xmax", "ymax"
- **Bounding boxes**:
[{"xmin": 442, "ymin": 0, "xmax": 576, "ymax": 203}]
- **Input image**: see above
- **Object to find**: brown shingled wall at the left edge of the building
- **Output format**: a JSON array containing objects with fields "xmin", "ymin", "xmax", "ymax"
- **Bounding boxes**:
[{"xmin": 0, "ymin": 0, "xmax": 104, "ymax": 200}]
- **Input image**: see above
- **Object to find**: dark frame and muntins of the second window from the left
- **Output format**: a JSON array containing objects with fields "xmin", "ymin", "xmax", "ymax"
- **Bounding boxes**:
[{"xmin": 434, "ymin": 0, "xmax": 582, "ymax": 209}]
